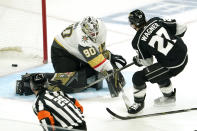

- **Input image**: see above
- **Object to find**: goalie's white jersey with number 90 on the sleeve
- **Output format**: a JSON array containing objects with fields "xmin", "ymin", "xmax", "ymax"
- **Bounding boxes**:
[{"xmin": 55, "ymin": 19, "xmax": 113, "ymax": 72}]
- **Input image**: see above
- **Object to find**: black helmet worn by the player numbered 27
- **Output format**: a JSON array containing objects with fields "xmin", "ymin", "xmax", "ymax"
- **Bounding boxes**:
[{"xmin": 128, "ymin": 9, "xmax": 146, "ymax": 28}]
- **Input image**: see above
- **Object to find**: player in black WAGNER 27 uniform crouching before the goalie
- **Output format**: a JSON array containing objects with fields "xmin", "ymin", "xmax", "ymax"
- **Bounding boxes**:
[{"xmin": 128, "ymin": 9, "xmax": 188, "ymax": 114}]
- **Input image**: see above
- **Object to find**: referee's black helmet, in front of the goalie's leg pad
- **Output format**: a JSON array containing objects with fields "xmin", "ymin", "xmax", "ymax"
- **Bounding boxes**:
[{"xmin": 30, "ymin": 73, "xmax": 48, "ymax": 91}]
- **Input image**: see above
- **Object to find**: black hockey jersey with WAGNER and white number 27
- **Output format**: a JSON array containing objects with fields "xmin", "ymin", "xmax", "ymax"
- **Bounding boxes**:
[{"xmin": 132, "ymin": 17, "xmax": 187, "ymax": 68}]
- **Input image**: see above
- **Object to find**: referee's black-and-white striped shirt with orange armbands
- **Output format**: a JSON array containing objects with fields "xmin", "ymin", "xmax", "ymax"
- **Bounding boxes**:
[{"xmin": 33, "ymin": 91, "xmax": 86, "ymax": 131}]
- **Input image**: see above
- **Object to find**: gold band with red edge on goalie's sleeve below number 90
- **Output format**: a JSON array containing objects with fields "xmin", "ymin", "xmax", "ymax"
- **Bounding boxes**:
[{"xmin": 88, "ymin": 54, "xmax": 106, "ymax": 68}]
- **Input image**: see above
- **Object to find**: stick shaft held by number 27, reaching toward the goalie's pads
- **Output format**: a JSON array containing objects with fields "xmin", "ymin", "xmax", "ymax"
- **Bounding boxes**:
[{"xmin": 84, "ymin": 62, "xmax": 134, "ymax": 89}]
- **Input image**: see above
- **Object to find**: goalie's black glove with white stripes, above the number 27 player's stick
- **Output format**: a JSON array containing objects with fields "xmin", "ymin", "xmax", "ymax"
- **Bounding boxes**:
[{"xmin": 111, "ymin": 54, "xmax": 127, "ymax": 67}]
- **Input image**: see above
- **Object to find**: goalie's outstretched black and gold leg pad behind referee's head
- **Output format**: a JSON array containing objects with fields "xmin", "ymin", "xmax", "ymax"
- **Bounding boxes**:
[{"xmin": 16, "ymin": 70, "xmax": 103, "ymax": 96}]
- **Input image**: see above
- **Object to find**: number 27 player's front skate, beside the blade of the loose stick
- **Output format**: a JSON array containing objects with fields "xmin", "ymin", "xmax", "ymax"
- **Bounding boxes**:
[{"xmin": 128, "ymin": 102, "xmax": 144, "ymax": 114}]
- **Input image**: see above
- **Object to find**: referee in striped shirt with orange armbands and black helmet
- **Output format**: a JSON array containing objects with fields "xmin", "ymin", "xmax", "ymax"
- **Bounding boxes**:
[{"xmin": 30, "ymin": 73, "xmax": 87, "ymax": 131}]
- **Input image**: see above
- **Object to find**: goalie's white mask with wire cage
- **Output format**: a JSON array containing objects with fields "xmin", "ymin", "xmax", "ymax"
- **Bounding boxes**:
[{"xmin": 81, "ymin": 16, "xmax": 99, "ymax": 42}]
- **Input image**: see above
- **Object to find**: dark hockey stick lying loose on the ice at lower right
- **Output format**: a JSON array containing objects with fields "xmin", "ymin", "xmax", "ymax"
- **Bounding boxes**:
[{"xmin": 106, "ymin": 107, "xmax": 197, "ymax": 120}]
